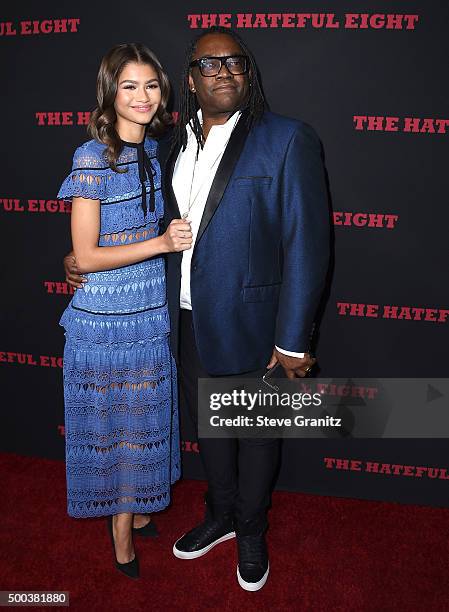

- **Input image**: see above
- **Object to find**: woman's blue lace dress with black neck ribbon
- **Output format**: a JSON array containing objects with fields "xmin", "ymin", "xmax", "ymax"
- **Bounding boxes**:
[{"xmin": 58, "ymin": 139, "xmax": 180, "ymax": 517}]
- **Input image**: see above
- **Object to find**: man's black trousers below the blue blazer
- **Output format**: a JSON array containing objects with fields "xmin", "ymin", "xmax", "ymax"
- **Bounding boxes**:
[{"xmin": 179, "ymin": 310, "xmax": 280, "ymax": 532}]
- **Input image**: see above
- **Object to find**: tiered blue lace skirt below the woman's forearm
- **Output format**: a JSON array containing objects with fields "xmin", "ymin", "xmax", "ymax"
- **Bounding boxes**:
[{"xmin": 60, "ymin": 258, "xmax": 180, "ymax": 517}]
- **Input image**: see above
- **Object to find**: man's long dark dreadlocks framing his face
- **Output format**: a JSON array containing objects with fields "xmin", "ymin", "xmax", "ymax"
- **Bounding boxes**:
[{"xmin": 173, "ymin": 26, "xmax": 267, "ymax": 151}]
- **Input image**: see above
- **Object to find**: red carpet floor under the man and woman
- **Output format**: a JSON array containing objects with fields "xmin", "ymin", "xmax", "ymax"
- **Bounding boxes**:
[{"xmin": 0, "ymin": 454, "xmax": 449, "ymax": 612}]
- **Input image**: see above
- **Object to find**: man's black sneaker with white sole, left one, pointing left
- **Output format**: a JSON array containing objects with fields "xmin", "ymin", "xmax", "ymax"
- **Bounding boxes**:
[{"xmin": 173, "ymin": 515, "xmax": 235, "ymax": 559}]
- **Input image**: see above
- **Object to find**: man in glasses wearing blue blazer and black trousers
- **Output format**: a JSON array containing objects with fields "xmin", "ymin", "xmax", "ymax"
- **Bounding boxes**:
[{"xmin": 68, "ymin": 27, "xmax": 329, "ymax": 591}]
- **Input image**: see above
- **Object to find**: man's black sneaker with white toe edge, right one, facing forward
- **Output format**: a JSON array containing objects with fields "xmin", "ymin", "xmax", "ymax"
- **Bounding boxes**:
[{"xmin": 237, "ymin": 532, "xmax": 270, "ymax": 591}]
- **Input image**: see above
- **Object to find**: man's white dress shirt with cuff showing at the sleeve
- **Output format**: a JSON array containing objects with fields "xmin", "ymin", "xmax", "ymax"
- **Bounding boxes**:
[{"xmin": 172, "ymin": 110, "xmax": 304, "ymax": 357}]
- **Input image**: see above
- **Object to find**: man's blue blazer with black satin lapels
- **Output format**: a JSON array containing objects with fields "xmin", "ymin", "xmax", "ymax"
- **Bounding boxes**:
[{"xmin": 164, "ymin": 112, "xmax": 329, "ymax": 375}]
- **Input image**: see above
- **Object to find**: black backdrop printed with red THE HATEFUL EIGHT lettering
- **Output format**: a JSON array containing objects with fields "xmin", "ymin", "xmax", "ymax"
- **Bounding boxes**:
[{"xmin": 0, "ymin": 0, "xmax": 449, "ymax": 506}]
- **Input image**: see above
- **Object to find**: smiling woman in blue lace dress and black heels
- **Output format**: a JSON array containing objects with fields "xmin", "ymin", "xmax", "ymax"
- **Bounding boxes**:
[{"xmin": 58, "ymin": 44, "xmax": 192, "ymax": 578}]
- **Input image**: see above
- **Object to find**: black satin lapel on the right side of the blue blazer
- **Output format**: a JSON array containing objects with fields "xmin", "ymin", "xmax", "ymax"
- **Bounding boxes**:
[{"xmin": 195, "ymin": 113, "xmax": 248, "ymax": 248}]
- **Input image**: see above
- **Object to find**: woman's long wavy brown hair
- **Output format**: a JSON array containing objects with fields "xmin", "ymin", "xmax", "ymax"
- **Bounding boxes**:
[{"xmin": 88, "ymin": 43, "xmax": 172, "ymax": 172}]
